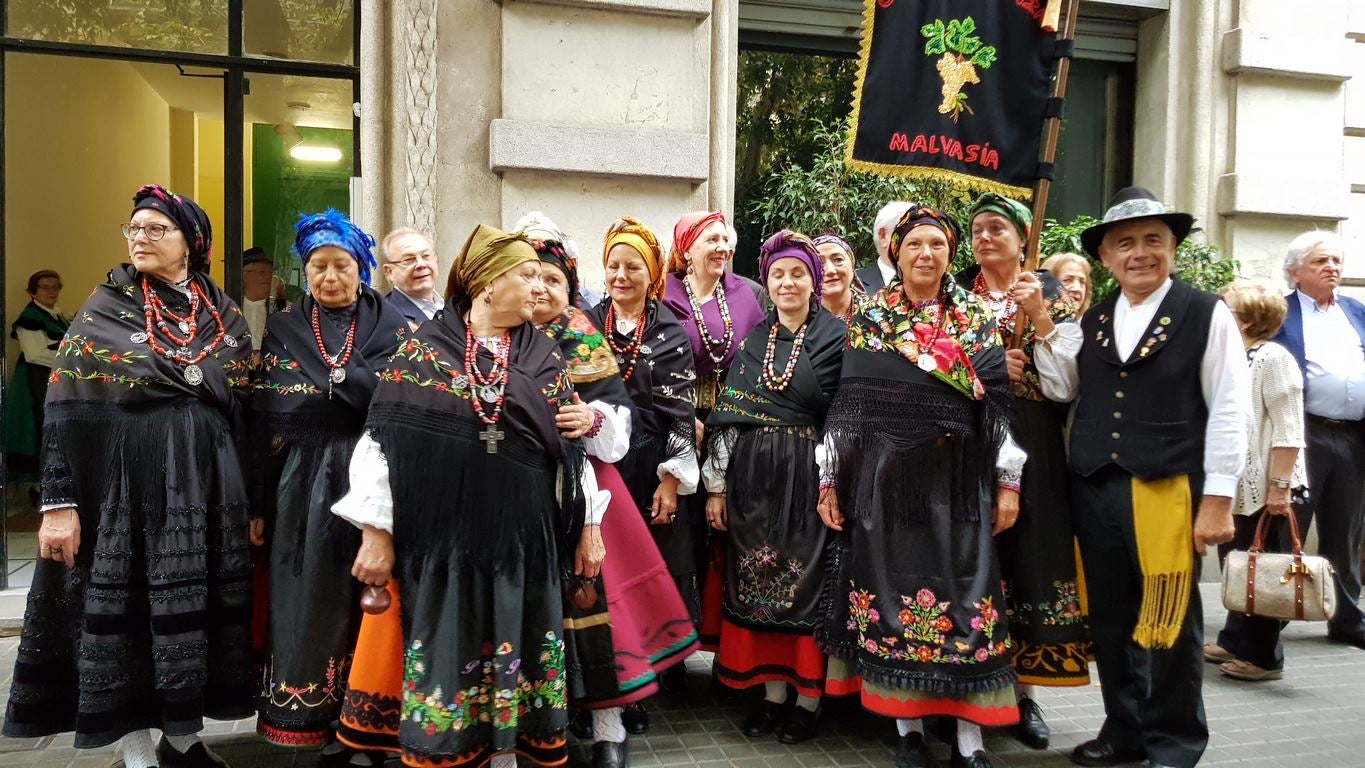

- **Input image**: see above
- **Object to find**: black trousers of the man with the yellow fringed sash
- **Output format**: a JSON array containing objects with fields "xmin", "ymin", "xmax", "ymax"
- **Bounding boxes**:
[{"xmin": 1072, "ymin": 465, "xmax": 1208, "ymax": 768}]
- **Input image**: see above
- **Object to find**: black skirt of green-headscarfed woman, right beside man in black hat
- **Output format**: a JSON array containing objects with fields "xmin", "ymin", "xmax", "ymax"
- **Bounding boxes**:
[{"xmin": 995, "ymin": 398, "xmax": 1089, "ymax": 686}]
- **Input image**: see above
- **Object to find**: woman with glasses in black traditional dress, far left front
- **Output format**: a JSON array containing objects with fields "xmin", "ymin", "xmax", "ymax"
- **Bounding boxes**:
[{"xmin": 4, "ymin": 184, "xmax": 253, "ymax": 768}]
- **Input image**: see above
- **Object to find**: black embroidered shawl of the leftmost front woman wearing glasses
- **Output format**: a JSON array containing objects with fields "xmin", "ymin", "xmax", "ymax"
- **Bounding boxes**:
[{"xmin": 42, "ymin": 265, "xmax": 251, "ymax": 509}]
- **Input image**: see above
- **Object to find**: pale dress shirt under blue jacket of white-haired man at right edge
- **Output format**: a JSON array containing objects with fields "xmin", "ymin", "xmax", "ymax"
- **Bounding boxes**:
[{"xmin": 1298, "ymin": 291, "xmax": 1365, "ymax": 422}]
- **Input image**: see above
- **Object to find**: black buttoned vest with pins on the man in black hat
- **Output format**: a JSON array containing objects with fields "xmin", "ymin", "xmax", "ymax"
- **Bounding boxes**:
[{"xmin": 1070, "ymin": 278, "xmax": 1219, "ymax": 480}]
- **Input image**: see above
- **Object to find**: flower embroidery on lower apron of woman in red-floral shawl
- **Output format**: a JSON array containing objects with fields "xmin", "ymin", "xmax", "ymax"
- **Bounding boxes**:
[{"xmin": 848, "ymin": 585, "xmax": 1013, "ymax": 664}]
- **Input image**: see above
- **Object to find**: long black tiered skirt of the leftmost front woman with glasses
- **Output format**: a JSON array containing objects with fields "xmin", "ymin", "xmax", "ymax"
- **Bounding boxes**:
[{"xmin": 4, "ymin": 398, "xmax": 253, "ymax": 748}]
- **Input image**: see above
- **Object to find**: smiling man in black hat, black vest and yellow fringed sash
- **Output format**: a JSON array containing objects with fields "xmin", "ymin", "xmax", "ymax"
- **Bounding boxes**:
[{"xmin": 1069, "ymin": 187, "xmax": 1250, "ymax": 768}]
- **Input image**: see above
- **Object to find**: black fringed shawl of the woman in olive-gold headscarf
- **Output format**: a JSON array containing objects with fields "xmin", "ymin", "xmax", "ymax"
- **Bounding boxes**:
[{"xmin": 364, "ymin": 303, "xmax": 584, "ymax": 578}]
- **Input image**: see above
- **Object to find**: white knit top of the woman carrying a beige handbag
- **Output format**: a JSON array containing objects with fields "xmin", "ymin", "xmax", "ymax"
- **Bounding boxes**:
[{"xmin": 1233, "ymin": 341, "xmax": 1308, "ymax": 514}]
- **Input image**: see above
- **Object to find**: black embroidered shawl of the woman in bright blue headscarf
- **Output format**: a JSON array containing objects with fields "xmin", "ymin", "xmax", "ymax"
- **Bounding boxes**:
[{"xmin": 250, "ymin": 285, "xmax": 410, "ymax": 520}]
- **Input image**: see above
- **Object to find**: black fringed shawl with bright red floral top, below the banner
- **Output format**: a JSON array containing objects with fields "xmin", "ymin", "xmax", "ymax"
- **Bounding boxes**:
[{"xmin": 826, "ymin": 278, "xmax": 1010, "ymax": 527}]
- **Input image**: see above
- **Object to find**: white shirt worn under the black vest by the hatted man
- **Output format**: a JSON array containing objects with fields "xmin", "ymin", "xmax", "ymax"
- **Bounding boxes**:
[{"xmin": 1073, "ymin": 278, "xmax": 1252, "ymax": 498}]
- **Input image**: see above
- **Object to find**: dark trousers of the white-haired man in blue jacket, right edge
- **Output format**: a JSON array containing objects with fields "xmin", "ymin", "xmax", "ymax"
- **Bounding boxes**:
[{"xmin": 1305, "ymin": 415, "xmax": 1365, "ymax": 633}]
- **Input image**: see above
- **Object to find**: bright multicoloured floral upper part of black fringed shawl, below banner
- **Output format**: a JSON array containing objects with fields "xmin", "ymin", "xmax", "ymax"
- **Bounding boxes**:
[{"xmin": 849, "ymin": 278, "xmax": 1001, "ymax": 400}]
